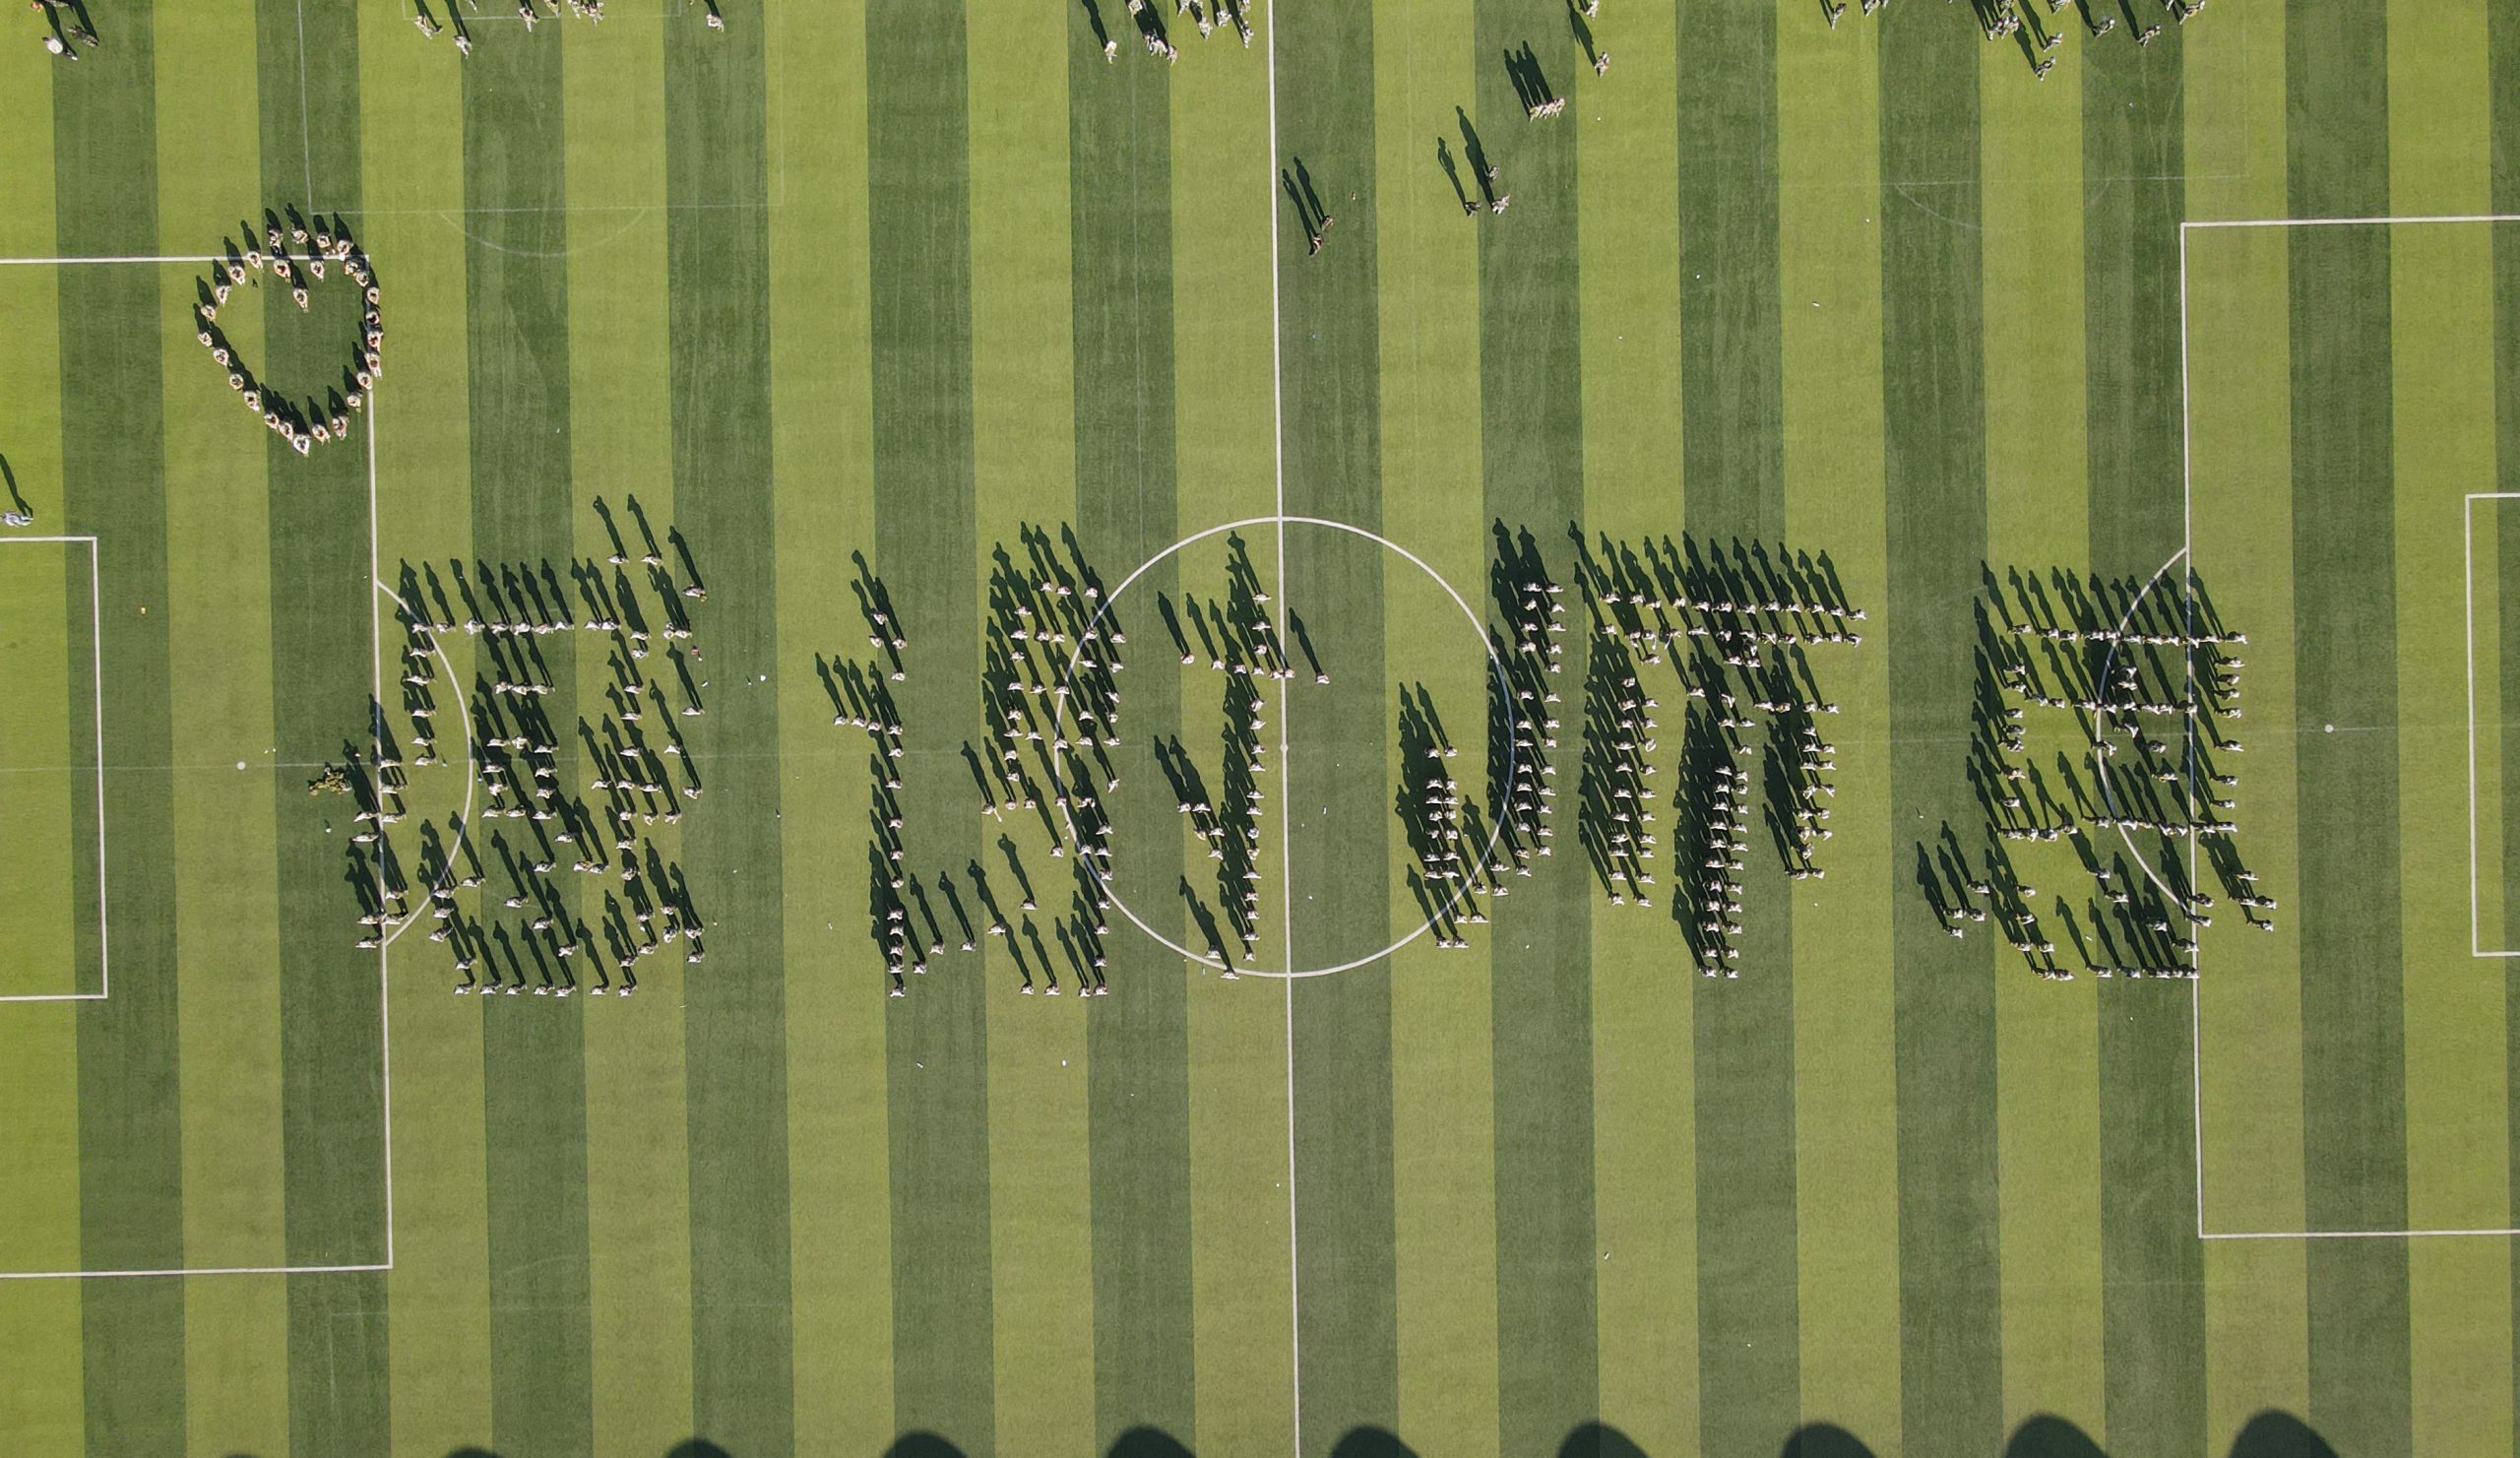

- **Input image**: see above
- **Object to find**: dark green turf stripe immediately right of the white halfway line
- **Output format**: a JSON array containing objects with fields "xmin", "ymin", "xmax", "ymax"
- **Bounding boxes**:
[{"xmin": 1290, "ymin": 5, "xmax": 1399, "ymax": 1453}]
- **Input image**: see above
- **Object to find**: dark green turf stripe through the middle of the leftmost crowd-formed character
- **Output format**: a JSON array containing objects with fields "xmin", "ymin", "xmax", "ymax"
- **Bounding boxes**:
[{"xmin": 451, "ymin": 26, "xmax": 592, "ymax": 1453}]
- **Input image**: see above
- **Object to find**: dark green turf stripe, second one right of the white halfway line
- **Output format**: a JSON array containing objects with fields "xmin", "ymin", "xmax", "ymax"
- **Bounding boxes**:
[{"xmin": 1461, "ymin": 0, "xmax": 1601, "ymax": 1453}]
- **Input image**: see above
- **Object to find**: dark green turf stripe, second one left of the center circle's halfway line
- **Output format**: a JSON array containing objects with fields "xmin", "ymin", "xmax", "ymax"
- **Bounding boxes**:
[{"xmin": 861, "ymin": 0, "xmax": 987, "ymax": 1453}]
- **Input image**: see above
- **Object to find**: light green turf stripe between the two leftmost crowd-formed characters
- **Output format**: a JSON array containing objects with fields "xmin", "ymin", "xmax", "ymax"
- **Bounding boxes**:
[{"xmin": 764, "ymin": 5, "xmax": 892, "ymax": 1453}]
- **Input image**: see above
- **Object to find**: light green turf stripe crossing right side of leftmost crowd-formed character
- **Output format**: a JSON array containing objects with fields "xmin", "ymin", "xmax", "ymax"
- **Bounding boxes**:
[{"xmin": 559, "ymin": 14, "xmax": 711, "ymax": 1453}]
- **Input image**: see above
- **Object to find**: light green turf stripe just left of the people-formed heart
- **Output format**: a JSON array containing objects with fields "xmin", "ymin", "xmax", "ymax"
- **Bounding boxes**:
[{"xmin": 157, "ymin": 0, "xmax": 289, "ymax": 1455}]
